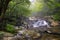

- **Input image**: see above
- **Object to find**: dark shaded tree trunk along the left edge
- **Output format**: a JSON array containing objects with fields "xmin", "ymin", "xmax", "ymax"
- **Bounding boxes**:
[{"xmin": 0, "ymin": 0, "xmax": 11, "ymax": 30}]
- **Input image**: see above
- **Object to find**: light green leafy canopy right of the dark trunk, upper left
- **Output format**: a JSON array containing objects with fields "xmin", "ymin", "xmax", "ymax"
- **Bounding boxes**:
[{"xmin": 6, "ymin": 0, "xmax": 30, "ymax": 16}]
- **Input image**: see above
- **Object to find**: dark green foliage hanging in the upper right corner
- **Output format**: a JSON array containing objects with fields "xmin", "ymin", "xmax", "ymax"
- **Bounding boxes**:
[{"xmin": 45, "ymin": 0, "xmax": 60, "ymax": 21}]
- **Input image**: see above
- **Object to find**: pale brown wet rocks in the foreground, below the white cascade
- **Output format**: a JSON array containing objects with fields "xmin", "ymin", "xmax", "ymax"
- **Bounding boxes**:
[{"xmin": 14, "ymin": 30, "xmax": 41, "ymax": 40}]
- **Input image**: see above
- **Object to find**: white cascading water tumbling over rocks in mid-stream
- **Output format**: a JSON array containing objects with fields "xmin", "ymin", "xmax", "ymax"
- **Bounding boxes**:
[{"xmin": 32, "ymin": 20, "xmax": 50, "ymax": 31}]
